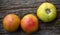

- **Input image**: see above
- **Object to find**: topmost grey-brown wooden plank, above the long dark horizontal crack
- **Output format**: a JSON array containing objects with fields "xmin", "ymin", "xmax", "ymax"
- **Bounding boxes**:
[{"xmin": 0, "ymin": 0, "xmax": 60, "ymax": 8}]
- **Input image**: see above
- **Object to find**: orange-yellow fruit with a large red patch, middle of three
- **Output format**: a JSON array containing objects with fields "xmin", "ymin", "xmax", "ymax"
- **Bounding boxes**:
[{"xmin": 21, "ymin": 14, "xmax": 38, "ymax": 33}]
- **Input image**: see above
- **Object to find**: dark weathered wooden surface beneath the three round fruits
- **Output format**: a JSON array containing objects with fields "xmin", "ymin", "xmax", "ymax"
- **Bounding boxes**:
[{"xmin": 0, "ymin": 0, "xmax": 60, "ymax": 35}]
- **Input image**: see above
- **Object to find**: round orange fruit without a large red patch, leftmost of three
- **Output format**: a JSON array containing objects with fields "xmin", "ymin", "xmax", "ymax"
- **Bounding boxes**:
[{"xmin": 3, "ymin": 14, "xmax": 20, "ymax": 32}]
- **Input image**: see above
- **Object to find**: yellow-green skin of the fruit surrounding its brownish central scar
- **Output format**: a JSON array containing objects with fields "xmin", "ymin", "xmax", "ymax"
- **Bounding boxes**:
[{"xmin": 37, "ymin": 2, "xmax": 57, "ymax": 22}]
